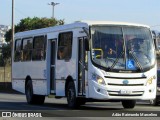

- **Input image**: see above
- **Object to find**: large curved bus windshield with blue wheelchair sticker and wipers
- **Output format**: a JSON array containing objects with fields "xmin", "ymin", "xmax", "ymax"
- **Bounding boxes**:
[{"xmin": 91, "ymin": 26, "xmax": 155, "ymax": 71}]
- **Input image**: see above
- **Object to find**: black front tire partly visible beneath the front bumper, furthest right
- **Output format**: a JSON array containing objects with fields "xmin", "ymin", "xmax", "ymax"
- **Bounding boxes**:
[{"xmin": 122, "ymin": 100, "xmax": 136, "ymax": 109}]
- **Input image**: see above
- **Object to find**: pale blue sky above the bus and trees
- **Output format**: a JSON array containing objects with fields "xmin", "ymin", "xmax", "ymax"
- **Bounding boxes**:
[{"xmin": 0, "ymin": 0, "xmax": 160, "ymax": 30}]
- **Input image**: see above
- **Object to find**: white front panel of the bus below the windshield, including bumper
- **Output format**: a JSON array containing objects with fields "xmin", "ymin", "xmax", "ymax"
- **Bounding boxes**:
[{"xmin": 88, "ymin": 58, "xmax": 157, "ymax": 100}]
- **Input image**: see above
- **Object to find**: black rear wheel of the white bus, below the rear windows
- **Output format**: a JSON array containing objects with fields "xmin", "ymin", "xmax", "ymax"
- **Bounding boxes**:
[{"xmin": 25, "ymin": 80, "xmax": 45, "ymax": 104}]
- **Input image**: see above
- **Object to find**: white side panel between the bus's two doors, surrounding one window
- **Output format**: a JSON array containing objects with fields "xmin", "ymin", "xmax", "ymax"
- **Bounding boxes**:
[{"xmin": 55, "ymin": 28, "xmax": 85, "ymax": 96}]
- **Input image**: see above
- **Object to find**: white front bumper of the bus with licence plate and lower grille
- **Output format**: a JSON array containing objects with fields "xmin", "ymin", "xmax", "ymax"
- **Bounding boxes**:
[{"xmin": 89, "ymin": 81, "xmax": 156, "ymax": 100}]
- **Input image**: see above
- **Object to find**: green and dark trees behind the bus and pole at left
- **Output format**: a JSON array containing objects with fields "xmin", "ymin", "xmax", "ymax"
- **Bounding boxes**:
[{"xmin": 0, "ymin": 17, "xmax": 64, "ymax": 65}]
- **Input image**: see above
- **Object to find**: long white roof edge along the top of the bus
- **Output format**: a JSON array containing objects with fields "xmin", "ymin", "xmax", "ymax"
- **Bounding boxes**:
[{"xmin": 15, "ymin": 21, "xmax": 149, "ymax": 38}]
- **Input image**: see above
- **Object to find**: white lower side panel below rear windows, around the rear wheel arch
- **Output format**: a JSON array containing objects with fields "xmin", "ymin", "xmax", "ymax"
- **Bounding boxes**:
[{"xmin": 12, "ymin": 51, "xmax": 47, "ymax": 95}]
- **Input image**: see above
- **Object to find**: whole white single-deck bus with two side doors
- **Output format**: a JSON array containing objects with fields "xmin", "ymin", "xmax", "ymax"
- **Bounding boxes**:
[{"xmin": 12, "ymin": 21, "xmax": 157, "ymax": 108}]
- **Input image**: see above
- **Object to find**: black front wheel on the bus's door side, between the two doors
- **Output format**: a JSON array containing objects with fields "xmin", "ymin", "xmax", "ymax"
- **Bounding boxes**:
[{"xmin": 67, "ymin": 81, "xmax": 80, "ymax": 109}]
